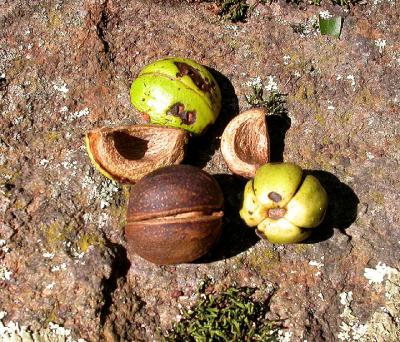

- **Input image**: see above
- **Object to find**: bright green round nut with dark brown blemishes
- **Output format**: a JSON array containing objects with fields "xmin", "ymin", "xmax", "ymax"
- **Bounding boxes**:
[{"xmin": 131, "ymin": 57, "xmax": 221, "ymax": 134}]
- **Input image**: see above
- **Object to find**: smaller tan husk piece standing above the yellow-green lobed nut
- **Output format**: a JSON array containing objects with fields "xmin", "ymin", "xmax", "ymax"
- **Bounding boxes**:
[{"xmin": 221, "ymin": 108, "xmax": 270, "ymax": 178}]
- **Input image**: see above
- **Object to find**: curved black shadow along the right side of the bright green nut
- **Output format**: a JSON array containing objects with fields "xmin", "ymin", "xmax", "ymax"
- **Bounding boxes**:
[{"xmin": 184, "ymin": 68, "xmax": 239, "ymax": 168}]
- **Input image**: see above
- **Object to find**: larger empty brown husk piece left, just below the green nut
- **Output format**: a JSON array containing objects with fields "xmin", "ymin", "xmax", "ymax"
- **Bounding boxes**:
[{"xmin": 85, "ymin": 125, "xmax": 186, "ymax": 183}]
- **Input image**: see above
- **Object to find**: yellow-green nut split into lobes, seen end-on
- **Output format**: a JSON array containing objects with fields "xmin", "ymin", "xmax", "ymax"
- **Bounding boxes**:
[{"xmin": 240, "ymin": 163, "xmax": 328, "ymax": 243}]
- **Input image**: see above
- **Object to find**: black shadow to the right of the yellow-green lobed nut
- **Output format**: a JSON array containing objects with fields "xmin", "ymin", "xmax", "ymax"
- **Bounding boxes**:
[{"xmin": 304, "ymin": 171, "xmax": 360, "ymax": 243}]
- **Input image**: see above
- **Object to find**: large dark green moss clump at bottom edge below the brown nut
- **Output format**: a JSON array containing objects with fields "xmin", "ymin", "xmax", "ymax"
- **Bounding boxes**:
[{"xmin": 161, "ymin": 281, "xmax": 278, "ymax": 342}]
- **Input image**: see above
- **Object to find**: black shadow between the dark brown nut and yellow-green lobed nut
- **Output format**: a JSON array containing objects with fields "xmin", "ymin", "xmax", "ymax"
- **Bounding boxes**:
[{"xmin": 196, "ymin": 174, "xmax": 259, "ymax": 263}]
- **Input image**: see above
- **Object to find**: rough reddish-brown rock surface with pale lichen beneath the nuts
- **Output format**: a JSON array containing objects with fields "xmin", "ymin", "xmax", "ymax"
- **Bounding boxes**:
[{"xmin": 0, "ymin": 0, "xmax": 400, "ymax": 341}]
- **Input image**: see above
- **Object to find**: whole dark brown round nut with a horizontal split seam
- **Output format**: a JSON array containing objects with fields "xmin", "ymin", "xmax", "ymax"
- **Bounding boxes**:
[{"xmin": 125, "ymin": 165, "xmax": 223, "ymax": 265}]
